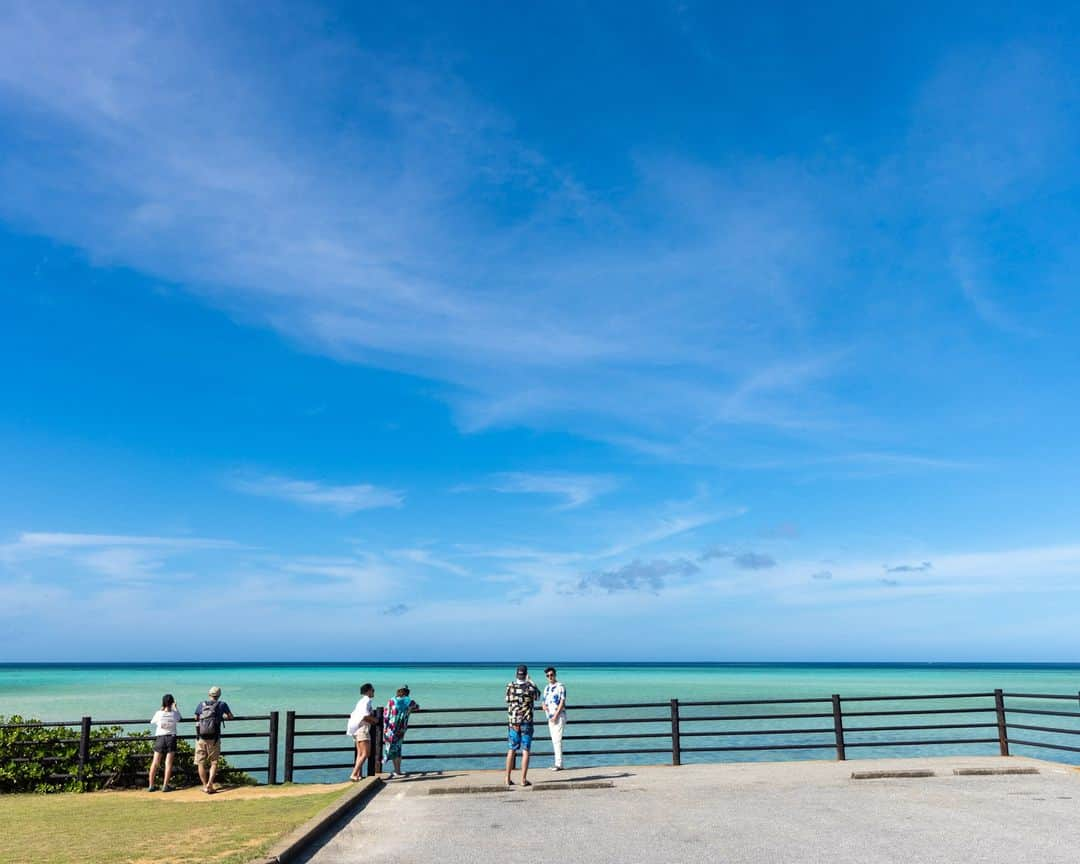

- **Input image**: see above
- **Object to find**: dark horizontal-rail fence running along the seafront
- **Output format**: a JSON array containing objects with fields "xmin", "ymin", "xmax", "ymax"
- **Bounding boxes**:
[{"xmin": 6, "ymin": 689, "xmax": 1080, "ymax": 783}]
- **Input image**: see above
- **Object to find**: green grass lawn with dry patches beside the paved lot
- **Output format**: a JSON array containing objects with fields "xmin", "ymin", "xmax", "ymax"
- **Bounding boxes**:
[{"xmin": 0, "ymin": 786, "xmax": 343, "ymax": 864}]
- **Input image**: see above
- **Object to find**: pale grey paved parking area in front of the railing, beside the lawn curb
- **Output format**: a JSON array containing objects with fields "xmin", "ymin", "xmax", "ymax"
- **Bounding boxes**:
[{"xmin": 306, "ymin": 757, "xmax": 1080, "ymax": 864}]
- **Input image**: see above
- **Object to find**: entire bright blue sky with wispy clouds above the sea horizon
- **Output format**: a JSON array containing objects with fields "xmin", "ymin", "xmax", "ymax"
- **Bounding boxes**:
[{"xmin": 0, "ymin": 0, "xmax": 1080, "ymax": 661}]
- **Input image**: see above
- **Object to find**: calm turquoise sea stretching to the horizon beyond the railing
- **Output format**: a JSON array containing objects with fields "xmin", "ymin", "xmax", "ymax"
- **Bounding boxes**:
[{"xmin": 0, "ymin": 662, "xmax": 1080, "ymax": 781}]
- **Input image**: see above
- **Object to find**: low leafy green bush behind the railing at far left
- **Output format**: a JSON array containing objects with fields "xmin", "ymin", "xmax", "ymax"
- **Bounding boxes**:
[{"xmin": 0, "ymin": 715, "xmax": 255, "ymax": 793}]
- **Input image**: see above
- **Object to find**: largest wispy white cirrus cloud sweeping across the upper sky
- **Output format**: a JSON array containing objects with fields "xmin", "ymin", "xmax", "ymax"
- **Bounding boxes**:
[{"xmin": 0, "ymin": 6, "xmax": 1076, "ymax": 457}]
